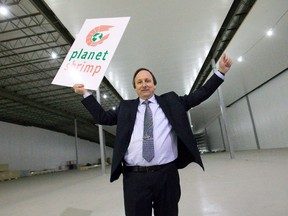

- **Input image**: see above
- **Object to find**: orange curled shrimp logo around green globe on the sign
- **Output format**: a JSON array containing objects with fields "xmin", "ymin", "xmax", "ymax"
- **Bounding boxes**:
[{"xmin": 86, "ymin": 25, "xmax": 114, "ymax": 46}]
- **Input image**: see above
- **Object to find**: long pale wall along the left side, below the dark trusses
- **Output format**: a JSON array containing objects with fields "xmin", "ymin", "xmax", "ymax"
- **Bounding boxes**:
[{"xmin": 0, "ymin": 122, "xmax": 112, "ymax": 170}]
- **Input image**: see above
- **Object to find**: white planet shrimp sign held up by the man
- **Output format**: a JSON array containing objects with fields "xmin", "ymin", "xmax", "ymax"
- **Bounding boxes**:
[{"xmin": 52, "ymin": 17, "xmax": 130, "ymax": 90}]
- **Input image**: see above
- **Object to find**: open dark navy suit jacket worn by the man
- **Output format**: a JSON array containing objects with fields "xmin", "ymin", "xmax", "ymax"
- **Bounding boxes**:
[{"xmin": 82, "ymin": 74, "xmax": 223, "ymax": 182}]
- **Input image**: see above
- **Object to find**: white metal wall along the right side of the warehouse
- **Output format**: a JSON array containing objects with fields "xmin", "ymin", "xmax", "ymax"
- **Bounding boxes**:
[{"xmin": 204, "ymin": 70, "xmax": 288, "ymax": 151}]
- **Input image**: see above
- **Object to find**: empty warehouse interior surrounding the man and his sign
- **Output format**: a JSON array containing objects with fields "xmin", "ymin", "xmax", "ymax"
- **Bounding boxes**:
[{"xmin": 0, "ymin": 0, "xmax": 288, "ymax": 216}]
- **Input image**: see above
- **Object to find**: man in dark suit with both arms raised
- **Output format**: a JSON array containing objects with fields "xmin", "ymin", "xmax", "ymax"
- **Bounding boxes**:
[{"xmin": 73, "ymin": 54, "xmax": 232, "ymax": 216}]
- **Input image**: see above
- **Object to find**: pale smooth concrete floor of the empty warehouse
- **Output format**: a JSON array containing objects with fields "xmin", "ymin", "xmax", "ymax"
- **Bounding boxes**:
[{"xmin": 0, "ymin": 149, "xmax": 288, "ymax": 216}]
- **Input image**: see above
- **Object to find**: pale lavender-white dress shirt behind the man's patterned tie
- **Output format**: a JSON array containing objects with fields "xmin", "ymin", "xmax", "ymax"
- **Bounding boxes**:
[{"xmin": 124, "ymin": 96, "xmax": 178, "ymax": 166}]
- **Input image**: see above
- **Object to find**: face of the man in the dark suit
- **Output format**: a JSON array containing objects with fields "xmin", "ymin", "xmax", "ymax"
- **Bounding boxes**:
[{"xmin": 134, "ymin": 70, "xmax": 155, "ymax": 100}]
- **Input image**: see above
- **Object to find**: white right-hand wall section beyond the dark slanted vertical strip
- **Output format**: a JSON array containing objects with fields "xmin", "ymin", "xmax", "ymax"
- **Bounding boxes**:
[{"xmin": 249, "ymin": 70, "xmax": 288, "ymax": 149}]
